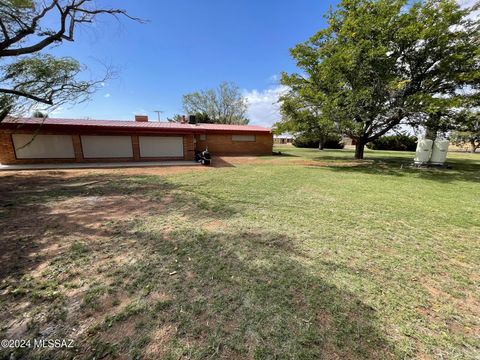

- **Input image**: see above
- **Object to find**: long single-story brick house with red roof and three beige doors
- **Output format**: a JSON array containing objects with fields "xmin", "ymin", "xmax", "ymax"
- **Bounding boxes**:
[{"xmin": 0, "ymin": 115, "xmax": 273, "ymax": 164}]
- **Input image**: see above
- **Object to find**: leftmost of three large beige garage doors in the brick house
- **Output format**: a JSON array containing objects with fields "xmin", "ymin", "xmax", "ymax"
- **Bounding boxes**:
[{"xmin": 12, "ymin": 134, "xmax": 75, "ymax": 159}]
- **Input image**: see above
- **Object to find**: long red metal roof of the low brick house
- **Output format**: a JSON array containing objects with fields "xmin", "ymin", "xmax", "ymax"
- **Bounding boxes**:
[{"xmin": 0, "ymin": 118, "xmax": 270, "ymax": 133}]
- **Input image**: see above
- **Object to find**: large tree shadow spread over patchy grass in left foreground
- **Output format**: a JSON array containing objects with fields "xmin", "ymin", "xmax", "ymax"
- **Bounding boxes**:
[{"xmin": 0, "ymin": 172, "xmax": 397, "ymax": 359}]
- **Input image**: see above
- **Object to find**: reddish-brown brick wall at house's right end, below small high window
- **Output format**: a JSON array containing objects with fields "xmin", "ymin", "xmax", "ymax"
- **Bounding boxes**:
[{"xmin": 195, "ymin": 133, "xmax": 273, "ymax": 155}]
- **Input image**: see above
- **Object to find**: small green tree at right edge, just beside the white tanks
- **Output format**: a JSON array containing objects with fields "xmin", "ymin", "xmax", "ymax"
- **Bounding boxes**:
[{"xmin": 451, "ymin": 110, "xmax": 480, "ymax": 153}]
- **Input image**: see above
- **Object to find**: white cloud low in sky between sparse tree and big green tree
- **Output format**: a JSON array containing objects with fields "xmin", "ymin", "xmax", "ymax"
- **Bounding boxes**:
[{"xmin": 244, "ymin": 85, "xmax": 287, "ymax": 127}]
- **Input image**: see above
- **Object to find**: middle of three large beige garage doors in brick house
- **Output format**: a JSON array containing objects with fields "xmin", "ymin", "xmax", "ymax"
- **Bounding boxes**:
[{"xmin": 81, "ymin": 135, "xmax": 133, "ymax": 158}]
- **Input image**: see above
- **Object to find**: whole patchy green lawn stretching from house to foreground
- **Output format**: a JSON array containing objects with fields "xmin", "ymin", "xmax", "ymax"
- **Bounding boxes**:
[{"xmin": 0, "ymin": 147, "xmax": 480, "ymax": 359}]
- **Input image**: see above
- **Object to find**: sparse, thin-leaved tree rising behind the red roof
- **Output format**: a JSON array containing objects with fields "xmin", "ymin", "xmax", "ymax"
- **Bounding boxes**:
[{"xmin": 183, "ymin": 82, "xmax": 249, "ymax": 125}]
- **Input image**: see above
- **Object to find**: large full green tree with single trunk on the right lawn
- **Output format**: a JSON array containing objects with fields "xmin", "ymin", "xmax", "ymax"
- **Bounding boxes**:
[{"xmin": 281, "ymin": 0, "xmax": 480, "ymax": 159}]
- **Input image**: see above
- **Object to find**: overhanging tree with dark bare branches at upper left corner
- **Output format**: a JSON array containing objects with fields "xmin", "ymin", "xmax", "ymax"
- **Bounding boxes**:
[{"xmin": 0, "ymin": 0, "xmax": 141, "ymax": 121}]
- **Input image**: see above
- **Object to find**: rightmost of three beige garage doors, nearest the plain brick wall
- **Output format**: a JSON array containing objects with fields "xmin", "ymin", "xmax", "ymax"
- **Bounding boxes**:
[{"xmin": 138, "ymin": 136, "xmax": 183, "ymax": 157}]
